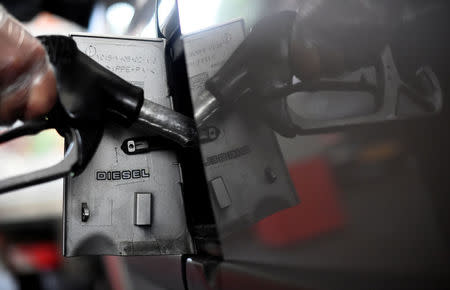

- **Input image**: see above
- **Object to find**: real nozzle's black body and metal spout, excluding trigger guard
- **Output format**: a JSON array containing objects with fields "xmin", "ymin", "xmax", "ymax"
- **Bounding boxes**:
[{"xmin": 39, "ymin": 36, "xmax": 197, "ymax": 146}]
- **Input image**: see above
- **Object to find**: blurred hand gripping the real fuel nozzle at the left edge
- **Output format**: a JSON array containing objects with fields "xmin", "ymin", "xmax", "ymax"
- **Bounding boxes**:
[{"xmin": 0, "ymin": 5, "xmax": 57, "ymax": 121}]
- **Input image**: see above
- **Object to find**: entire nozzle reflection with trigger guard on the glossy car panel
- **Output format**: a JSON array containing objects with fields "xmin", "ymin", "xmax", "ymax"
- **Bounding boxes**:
[{"xmin": 200, "ymin": 12, "xmax": 442, "ymax": 137}]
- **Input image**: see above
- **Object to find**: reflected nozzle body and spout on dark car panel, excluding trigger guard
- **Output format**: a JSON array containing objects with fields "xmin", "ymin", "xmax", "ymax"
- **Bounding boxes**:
[{"xmin": 202, "ymin": 11, "xmax": 296, "ymax": 121}]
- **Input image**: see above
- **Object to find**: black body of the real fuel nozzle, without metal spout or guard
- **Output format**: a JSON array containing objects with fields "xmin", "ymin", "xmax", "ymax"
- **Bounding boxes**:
[{"xmin": 39, "ymin": 35, "xmax": 144, "ymax": 126}]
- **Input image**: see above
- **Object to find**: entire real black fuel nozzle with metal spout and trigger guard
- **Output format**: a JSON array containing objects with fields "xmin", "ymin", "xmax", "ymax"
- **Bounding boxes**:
[{"xmin": 0, "ymin": 35, "xmax": 197, "ymax": 194}]
